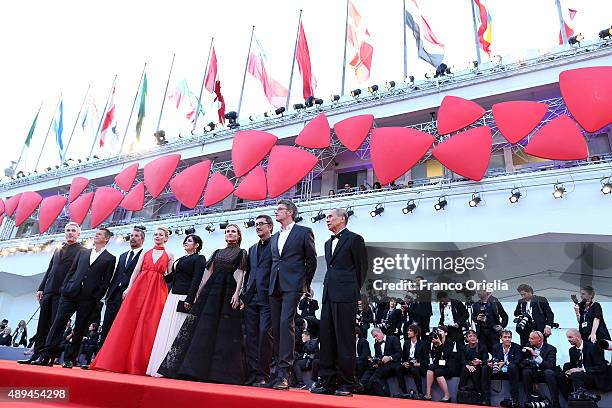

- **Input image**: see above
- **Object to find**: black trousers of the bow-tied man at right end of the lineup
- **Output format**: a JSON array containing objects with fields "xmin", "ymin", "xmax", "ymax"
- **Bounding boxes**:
[{"xmin": 319, "ymin": 302, "xmax": 357, "ymax": 386}]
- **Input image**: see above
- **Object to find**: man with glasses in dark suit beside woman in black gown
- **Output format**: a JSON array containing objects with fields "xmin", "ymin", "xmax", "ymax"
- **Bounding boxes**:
[{"xmin": 241, "ymin": 215, "xmax": 274, "ymax": 385}]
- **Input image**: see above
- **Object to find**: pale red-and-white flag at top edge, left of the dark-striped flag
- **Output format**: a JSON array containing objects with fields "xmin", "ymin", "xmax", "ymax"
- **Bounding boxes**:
[{"xmin": 346, "ymin": 0, "xmax": 374, "ymax": 83}]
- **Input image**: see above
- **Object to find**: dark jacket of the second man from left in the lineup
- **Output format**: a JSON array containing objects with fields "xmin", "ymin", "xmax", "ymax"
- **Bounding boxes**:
[{"xmin": 62, "ymin": 249, "xmax": 115, "ymax": 301}]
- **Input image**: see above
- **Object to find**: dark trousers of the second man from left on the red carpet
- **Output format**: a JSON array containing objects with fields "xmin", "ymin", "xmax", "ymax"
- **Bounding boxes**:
[{"xmin": 40, "ymin": 296, "xmax": 98, "ymax": 361}]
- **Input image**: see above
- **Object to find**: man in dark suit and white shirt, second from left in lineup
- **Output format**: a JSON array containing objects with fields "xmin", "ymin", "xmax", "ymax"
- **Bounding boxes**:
[{"xmin": 32, "ymin": 228, "xmax": 115, "ymax": 368}]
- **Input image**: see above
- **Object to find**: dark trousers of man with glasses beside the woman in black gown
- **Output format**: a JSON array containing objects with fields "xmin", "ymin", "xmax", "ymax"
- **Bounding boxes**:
[{"xmin": 244, "ymin": 299, "xmax": 273, "ymax": 381}]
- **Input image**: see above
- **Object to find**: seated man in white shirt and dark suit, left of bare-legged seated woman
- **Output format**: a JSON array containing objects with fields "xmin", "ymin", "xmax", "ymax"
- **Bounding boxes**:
[{"xmin": 397, "ymin": 324, "xmax": 427, "ymax": 398}]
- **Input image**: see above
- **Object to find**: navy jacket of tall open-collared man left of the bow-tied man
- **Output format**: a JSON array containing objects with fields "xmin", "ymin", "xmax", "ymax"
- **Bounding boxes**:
[{"xmin": 268, "ymin": 224, "xmax": 317, "ymax": 295}]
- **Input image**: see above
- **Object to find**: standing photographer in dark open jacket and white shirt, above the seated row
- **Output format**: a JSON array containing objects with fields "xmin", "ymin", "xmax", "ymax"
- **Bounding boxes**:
[{"xmin": 514, "ymin": 283, "xmax": 555, "ymax": 346}]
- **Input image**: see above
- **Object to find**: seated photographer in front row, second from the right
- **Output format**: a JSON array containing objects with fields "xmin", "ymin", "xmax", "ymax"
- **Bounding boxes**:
[{"xmin": 521, "ymin": 331, "xmax": 560, "ymax": 407}]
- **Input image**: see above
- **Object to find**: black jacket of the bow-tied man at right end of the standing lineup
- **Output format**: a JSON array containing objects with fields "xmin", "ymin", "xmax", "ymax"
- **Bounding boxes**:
[{"xmin": 322, "ymin": 229, "xmax": 368, "ymax": 303}]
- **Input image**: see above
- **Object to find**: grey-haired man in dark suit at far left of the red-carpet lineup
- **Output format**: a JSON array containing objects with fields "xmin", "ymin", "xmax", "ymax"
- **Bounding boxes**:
[{"xmin": 18, "ymin": 222, "xmax": 83, "ymax": 364}]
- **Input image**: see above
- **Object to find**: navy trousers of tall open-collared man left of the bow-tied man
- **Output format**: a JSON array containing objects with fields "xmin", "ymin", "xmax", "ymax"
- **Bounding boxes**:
[{"xmin": 270, "ymin": 291, "xmax": 304, "ymax": 378}]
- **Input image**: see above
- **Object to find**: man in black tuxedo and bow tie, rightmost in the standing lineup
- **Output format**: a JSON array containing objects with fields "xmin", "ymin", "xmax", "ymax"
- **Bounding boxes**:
[{"xmin": 312, "ymin": 208, "xmax": 368, "ymax": 396}]
